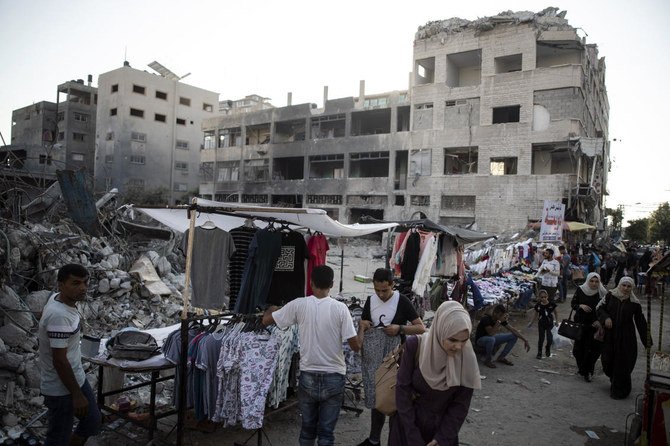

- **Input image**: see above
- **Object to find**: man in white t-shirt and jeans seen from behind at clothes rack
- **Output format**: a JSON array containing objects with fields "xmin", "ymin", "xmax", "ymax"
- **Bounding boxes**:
[{"xmin": 263, "ymin": 265, "xmax": 360, "ymax": 446}]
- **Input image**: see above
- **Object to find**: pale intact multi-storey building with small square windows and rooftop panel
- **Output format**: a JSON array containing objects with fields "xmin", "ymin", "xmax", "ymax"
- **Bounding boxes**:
[{"xmin": 95, "ymin": 62, "xmax": 219, "ymax": 203}]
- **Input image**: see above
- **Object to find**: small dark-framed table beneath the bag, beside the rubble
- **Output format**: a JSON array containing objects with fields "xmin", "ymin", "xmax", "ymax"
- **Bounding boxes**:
[{"xmin": 83, "ymin": 355, "xmax": 177, "ymax": 440}]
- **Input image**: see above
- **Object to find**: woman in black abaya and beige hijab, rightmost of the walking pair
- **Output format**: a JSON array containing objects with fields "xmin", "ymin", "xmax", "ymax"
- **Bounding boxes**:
[{"xmin": 598, "ymin": 277, "xmax": 651, "ymax": 399}]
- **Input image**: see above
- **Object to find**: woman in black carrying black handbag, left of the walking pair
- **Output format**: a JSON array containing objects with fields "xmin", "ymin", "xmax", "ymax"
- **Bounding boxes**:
[{"xmin": 570, "ymin": 273, "xmax": 607, "ymax": 382}]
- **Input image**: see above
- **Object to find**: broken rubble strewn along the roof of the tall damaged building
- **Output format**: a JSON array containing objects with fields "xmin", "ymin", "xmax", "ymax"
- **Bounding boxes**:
[{"xmin": 414, "ymin": 7, "xmax": 573, "ymax": 40}]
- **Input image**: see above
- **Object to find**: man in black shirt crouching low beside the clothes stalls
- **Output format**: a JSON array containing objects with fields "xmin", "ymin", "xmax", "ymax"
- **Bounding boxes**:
[{"xmin": 475, "ymin": 305, "xmax": 530, "ymax": 369}]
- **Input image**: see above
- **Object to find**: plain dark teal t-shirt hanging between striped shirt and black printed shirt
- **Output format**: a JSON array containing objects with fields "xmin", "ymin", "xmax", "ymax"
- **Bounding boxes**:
[{"xmin": 235, "ymin": 229, "xmax": 282, "ymax": 314}]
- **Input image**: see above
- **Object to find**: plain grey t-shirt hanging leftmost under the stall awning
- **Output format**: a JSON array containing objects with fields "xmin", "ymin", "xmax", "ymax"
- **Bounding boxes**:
[{"xmin": 184, "ymin": 227, "xmax": 235, "ymax": 310}]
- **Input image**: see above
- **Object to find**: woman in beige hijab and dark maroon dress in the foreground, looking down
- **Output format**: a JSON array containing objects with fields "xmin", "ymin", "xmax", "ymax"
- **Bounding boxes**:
[{"xmin": 388, "ymin": 301, "xmax": 481, "ymax": 446}]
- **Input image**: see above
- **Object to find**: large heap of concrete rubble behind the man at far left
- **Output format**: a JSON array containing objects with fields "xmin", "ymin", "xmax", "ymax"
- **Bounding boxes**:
[{"xmin": 0, "ymin": 219, "xmax": 189, "ymax": 438}]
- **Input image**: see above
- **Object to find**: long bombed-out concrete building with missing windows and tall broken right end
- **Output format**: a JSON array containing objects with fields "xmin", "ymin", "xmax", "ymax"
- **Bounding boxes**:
[{"xmin": 200, "ymin": 8, "xmax": 609, "ymax": 232}]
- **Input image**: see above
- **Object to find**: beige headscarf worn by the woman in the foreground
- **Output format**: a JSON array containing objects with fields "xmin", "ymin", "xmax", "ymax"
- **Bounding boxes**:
[{"xmin": 419, "ymin": 301, "xmax": 482, "ymax": 390}]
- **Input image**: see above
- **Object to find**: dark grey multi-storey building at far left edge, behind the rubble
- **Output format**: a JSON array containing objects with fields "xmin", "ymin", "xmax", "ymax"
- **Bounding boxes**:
[{"xmin": 0, "ymin": 75, "xmax": 98, "ymax": 186}]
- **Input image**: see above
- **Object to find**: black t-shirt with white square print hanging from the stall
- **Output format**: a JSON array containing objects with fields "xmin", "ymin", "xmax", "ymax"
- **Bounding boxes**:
[{"xmin": 266, "ymin": 231, "xmax": 309, "ymax": 305}]
